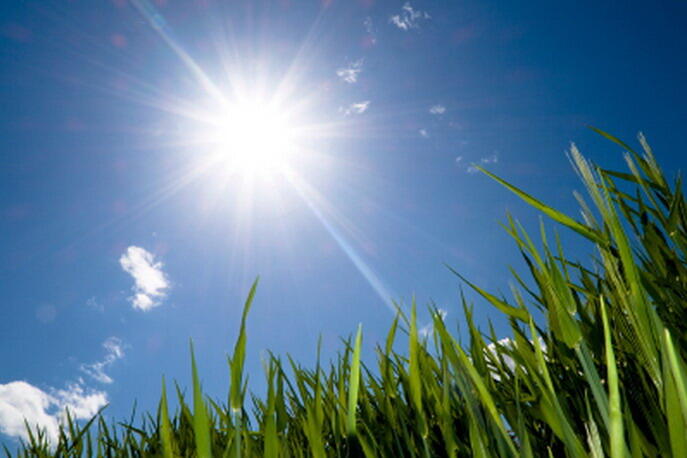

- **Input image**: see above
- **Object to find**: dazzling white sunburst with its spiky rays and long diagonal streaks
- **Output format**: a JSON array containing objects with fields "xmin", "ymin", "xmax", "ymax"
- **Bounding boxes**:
[{"xmin": 125, "ymin": 0, "xmax": 398, "ymax": 314}]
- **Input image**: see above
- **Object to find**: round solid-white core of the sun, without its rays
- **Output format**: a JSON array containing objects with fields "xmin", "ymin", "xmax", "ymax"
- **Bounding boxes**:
[{"xmin": 204, "ymin": 100, "xmax": 295, "ymax": 175}]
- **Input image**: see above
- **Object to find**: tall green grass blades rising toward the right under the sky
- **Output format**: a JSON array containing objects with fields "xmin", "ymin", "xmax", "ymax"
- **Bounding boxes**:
[{"xmin": 6, "ymin": 131, "xmax": 687, "ymax": 458}]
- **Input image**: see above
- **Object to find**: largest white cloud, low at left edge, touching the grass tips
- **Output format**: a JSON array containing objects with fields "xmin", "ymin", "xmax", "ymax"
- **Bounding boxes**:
[{"xmin": 0, "ymin": 381, "xmax": 107, "ymax": 443}]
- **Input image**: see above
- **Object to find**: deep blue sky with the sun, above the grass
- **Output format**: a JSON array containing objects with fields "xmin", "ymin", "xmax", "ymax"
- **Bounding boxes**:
[{"xmin": 0, "ymin": 0, "xmax": 687, "ymax": 444}]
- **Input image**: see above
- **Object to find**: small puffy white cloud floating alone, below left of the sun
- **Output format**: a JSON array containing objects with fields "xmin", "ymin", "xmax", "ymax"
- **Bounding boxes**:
[{"xmin": 119, "ymin": 246, "xmax": 169, "ymax": 311}]
